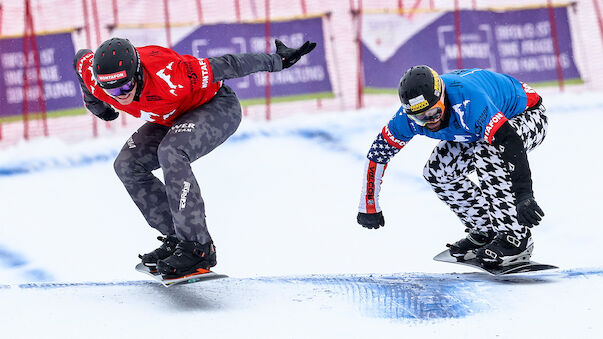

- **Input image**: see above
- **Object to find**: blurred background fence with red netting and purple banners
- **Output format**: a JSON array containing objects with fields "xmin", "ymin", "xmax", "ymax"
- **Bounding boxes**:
[{"xmin": 0, "ymin": 0, "xmax": 603, "ymax": 147}]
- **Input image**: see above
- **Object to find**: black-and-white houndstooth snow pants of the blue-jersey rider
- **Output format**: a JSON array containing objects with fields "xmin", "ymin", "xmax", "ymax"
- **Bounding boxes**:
[{"xmin": 423, "ymin": 104, "xmax": 548, "ymax": 238}]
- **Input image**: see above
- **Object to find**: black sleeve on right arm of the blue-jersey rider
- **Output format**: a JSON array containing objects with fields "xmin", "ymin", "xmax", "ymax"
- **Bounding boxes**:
[{"xmin": 492, "ymin": 121, "xmax": 533, "ymax": 201}]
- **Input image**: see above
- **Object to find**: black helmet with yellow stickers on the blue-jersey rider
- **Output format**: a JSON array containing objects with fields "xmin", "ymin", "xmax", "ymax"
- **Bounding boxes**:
[{"xmin": 398, "ymin": 65, "xmax": 444, "ymax": 114}]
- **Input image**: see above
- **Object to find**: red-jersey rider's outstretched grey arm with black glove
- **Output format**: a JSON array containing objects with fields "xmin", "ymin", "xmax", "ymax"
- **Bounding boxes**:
[{"xmin": 208, "ymin": 40, "xmax": 316, "ymax": 82}]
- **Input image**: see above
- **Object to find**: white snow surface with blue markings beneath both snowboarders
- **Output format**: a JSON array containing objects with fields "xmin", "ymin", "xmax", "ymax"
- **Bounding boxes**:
[{"xmin": 0, "ymin": 93, "xmax": 603, "ymax": 338}]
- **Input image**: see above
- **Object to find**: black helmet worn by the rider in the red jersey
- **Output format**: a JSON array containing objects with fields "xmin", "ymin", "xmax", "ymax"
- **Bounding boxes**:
[{"xmin": 92, "ymin": 38, "xmax": 140, "ymax": 88}]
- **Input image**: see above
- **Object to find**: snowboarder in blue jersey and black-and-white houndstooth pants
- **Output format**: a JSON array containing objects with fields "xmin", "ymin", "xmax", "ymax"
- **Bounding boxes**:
[{"xmin": 357, "ymin": 66, "xmax": 547, "ymax": 267}]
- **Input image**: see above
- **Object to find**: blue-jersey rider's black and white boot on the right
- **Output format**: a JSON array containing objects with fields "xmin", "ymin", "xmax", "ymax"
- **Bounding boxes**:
[{"xmin": 476, "ymin": 229, "xmax": 534, "ymax": 267}]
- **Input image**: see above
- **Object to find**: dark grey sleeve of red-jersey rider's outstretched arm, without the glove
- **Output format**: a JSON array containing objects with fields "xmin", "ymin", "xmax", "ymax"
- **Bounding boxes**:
[{"xmin": 208, "ymin": 53, "xmax": 283, "ymax": 82}]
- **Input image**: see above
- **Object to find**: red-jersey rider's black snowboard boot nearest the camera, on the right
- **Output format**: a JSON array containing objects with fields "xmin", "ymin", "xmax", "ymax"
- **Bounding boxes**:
[{"xmin": 157, "ymin": 241, "xmax": 217, "ymax": 279}]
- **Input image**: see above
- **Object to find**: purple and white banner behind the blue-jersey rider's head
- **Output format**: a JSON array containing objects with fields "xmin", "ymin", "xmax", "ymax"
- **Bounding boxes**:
[{"xmin": 362, "ymin": 7, "xmax": 580, "ymax": 89}]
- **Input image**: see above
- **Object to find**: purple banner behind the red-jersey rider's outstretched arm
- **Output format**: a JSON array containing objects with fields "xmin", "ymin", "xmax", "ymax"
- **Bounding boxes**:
[{"xmin": 174, "ymin": 18, "xmax": 332, "ymax": 100}]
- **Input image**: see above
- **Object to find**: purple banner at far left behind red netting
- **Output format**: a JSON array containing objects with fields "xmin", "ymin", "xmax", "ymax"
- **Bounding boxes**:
[{"xmin": 0, "ymin": 33, "xmax": 83, "ymax": 118}]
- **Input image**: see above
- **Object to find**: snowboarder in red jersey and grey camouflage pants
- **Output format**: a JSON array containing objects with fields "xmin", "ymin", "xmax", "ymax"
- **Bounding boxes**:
[{"xmin": 74, "ymin": 38, "xmax": 316, "ymax": 278}]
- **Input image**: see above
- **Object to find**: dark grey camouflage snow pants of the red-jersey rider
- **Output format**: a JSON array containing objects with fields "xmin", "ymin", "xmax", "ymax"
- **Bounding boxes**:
[{"xmin": 114, "ymin": 86, "xmax": 241, "ymax": 243}]
